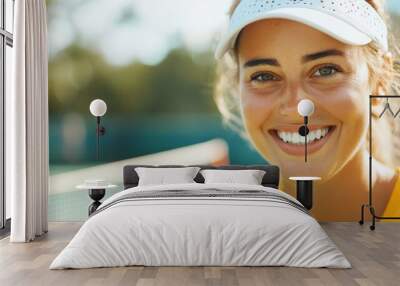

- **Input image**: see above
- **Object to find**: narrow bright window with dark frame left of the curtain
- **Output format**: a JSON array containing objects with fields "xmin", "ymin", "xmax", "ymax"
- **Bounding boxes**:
[{"xmin": 0, "ymin": 0, "xmax": 14, "ymax": 232}]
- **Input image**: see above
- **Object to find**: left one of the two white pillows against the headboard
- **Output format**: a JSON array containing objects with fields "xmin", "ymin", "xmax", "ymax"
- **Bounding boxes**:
[{"xmin": 135, "ymin": 167, "xmax": 200, "ymax": 186}]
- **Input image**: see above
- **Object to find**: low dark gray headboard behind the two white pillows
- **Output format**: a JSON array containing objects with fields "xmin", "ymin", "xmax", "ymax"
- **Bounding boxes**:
[{"xmin": 124, "ymin": 165, "xmax": 279, "ymax": 189}]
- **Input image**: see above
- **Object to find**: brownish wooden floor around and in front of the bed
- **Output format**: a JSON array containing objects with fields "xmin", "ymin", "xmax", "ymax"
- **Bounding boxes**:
[{"xmin": 0, "ymin": 223, "xmax": 400, "ymax": 286}]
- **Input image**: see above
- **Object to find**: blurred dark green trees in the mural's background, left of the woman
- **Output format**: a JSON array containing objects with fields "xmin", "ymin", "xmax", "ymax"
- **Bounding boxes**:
[{"xmin": 49, "ymin": 44, "xmax": 216, "ymax": 114}]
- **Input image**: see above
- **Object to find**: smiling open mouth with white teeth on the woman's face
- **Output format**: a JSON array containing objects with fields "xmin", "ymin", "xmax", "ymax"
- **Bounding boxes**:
[{"xmin": 268, "ymin": 125, "xmax": 336, "ymax": 156}]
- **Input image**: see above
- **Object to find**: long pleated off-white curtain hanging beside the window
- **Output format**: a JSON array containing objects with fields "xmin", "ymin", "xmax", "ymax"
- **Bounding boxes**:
[{"xmin": 6, "ymin": 0, "xmax": 49, "ymax": 242}]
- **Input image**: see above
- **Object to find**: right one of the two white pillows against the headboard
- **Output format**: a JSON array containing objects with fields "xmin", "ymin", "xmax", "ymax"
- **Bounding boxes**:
[{"xmin": 200, "ymin": 169, "xmax": 265, "ymax": 185}]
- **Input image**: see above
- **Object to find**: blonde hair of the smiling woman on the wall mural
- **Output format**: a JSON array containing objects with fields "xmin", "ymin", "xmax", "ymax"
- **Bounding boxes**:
[{"xmin": 214, "ymin": 0, "xmax": 400, "ymax": 167}]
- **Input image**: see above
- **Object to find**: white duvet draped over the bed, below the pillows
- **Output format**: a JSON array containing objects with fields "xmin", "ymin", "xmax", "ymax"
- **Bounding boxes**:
[{"xmin": 50, "ymin": 183, "xmax": 351, "ymax": 269}]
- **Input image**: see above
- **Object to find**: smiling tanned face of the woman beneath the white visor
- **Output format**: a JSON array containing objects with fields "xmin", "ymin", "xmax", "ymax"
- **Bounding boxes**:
[{"xmin": 238, "ymin": 19, "xmax": 370, "ymax": 180}]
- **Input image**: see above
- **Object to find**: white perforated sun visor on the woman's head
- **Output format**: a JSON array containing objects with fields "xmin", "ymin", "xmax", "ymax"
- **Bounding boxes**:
[{"xmin": 215, "ymin": 0, "xmax": 388, "ymax": 59}]
